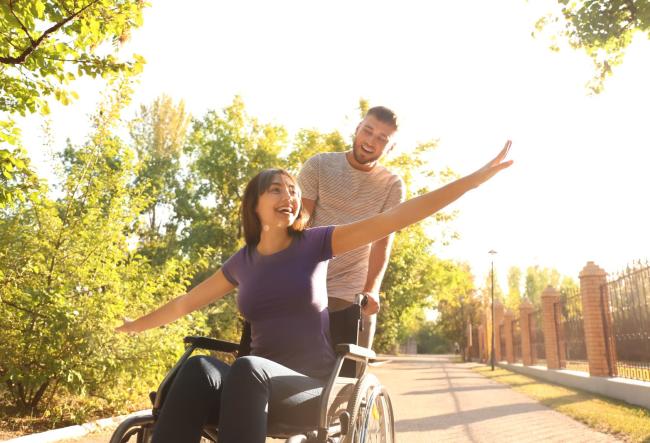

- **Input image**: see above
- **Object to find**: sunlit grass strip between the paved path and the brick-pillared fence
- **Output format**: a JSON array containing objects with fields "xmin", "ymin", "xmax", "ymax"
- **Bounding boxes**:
[{"xmin": 473, "ymin": 366, "xmax": 650, "ymax": 443}]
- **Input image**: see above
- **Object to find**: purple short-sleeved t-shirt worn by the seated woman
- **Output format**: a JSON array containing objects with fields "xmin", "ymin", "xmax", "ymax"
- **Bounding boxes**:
[{"xmin": 222, "ymin": 226, "xmax": 335, "ymax": 377}]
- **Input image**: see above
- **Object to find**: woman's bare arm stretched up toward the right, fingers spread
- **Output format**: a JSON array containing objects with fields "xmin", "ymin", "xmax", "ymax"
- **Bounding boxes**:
[{"xmin": 332, "ymin": 140, "xmax": 512, "ymax": 255}]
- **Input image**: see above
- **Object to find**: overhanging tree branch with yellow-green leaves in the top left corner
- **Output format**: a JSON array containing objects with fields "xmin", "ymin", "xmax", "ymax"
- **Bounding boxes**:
[{"xmin": 0, "ymin": 0, "xmax": 145, "ymax": 205}]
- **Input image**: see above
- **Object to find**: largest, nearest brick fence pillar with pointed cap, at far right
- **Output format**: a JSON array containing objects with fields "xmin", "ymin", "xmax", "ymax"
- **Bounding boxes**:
[{"xmin": 580, "ymin": 261, "xmax": 616, "ymax": 377}]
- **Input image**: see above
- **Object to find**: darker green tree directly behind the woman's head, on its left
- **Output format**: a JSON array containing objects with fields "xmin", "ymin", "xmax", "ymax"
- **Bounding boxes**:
[{"xmin": 174, "ymin": 97, "xmax": 287, "ymax": 339}]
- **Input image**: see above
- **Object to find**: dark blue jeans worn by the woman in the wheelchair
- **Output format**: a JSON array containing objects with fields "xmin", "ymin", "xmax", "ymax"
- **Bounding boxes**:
[{"xmin": 153, "ymin": 356, "xmax": 326, "ymax": 443}]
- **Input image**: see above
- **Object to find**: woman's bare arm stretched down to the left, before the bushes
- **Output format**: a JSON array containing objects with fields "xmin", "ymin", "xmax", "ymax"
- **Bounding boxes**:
[{"xmin": 116, "ymin": 269, "xmax": 235, "ymax": 332}]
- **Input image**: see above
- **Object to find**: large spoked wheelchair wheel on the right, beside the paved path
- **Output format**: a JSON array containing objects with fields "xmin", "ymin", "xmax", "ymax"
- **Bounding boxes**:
[{"xmin": 344, "ymin": 374, "xmax": 395, "ymax": 443}]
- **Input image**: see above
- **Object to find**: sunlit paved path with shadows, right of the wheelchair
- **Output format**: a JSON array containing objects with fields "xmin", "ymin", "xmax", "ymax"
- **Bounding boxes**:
[{"xmin": 372, "ymin": 356, "xmax": 619, "ymax": 443}]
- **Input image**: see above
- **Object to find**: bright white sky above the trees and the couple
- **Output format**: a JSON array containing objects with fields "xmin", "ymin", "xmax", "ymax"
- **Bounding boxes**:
[{"xmin": 17, "ymin": 0, "xmax": 650, "ymax": 294}]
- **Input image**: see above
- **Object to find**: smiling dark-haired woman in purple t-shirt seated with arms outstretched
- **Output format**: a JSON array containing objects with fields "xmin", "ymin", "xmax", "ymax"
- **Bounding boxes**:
[{"xmin": 117, "ymin": 141, "xmax": 512, "ymax": 443}]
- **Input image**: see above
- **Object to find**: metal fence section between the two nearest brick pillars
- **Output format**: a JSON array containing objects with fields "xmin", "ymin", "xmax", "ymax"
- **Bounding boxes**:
[{"xmin": 557, "ymin": 288, "xmax": 589, "ymax": 372}]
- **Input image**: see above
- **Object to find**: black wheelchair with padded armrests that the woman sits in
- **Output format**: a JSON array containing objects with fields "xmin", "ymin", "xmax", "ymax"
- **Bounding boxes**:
[{"xmin": 110, "ymin": 300, "xmax": 395, "ymax": 443}]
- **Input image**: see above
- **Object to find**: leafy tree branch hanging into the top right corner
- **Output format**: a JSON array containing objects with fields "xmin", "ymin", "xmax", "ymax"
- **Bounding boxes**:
[{"xmin": 536, "ymin": 0, "xmax": 650, "ymax": 93}]
